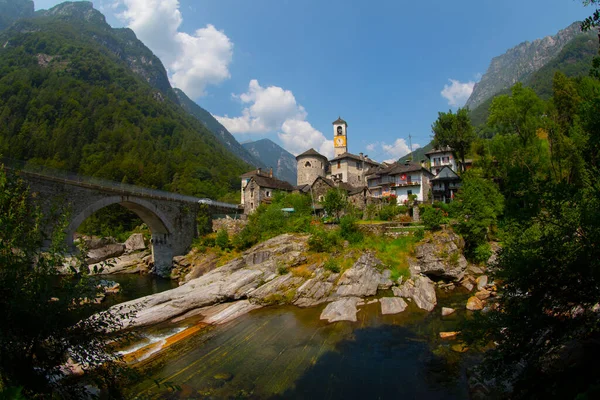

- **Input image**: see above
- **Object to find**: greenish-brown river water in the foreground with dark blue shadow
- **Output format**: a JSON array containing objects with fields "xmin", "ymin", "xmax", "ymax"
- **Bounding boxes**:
[{"xmin": 125, "ymin": 292, "xmax": 476, "ymax": 399}]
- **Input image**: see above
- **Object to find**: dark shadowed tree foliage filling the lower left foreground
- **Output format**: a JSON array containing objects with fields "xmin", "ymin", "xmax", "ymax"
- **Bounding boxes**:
[{"xmin": 0, "ymin": 166, "xmax": 132, "ymax": 398}]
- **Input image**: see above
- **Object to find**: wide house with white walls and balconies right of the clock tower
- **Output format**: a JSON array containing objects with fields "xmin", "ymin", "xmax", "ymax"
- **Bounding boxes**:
[{"xmin": 366, "ymin": 161, "xmax": 433, "ymax": 203}]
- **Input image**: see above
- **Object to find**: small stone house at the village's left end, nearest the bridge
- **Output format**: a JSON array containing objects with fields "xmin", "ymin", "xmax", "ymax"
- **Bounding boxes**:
[{"xmin": 241, "ymin": 168, "xmax": 294, "ymax": 214}]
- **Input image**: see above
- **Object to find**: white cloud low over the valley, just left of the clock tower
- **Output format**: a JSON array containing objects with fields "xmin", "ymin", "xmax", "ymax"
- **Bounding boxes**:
[{"xmin": 215, "ymin": 79, "xmax": 333, "ymax": 157}]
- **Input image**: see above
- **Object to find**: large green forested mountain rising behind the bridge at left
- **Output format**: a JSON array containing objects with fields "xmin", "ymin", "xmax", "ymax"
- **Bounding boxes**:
[{"xmin": 0, "ymin": 2, "xmax": 251, "ymax": 198}]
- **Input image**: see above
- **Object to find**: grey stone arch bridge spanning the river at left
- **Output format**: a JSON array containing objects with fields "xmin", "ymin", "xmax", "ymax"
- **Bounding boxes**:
[{"xmin": 7, "ymin": 164, "xmax": 238, "ymax": 276}]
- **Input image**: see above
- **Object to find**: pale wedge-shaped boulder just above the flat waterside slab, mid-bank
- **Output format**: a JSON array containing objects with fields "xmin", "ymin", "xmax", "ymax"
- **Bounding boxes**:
[{"xmin": 336, "ymin": 253, "xmax": 384, "ymax": 297}]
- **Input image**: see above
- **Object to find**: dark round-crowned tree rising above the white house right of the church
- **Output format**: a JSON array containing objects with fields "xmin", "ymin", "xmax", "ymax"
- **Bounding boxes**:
[{"xmin": 431, "ymin": 108, "xmax": 475, "ymax": 168}]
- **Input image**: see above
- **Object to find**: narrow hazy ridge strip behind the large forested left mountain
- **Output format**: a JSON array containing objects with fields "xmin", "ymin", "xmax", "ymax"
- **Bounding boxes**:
[{"xmin": 174, "ymin": 88, "xmax": 265, "ymax": 168}]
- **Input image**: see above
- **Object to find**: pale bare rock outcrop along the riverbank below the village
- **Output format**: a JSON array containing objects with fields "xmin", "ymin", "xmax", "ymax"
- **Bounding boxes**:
[{"xmin": 106, "ymin": 230, "xmax": 495, "ymax": 327}]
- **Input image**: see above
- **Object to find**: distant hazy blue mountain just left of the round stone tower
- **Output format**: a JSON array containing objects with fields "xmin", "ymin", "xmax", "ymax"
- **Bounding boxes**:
[{"xmin": 242, "ymin": 139, "xmax": 297, "ymax": 185}]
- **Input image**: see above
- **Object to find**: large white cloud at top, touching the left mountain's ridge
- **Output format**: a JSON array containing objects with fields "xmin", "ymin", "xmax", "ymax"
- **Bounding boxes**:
[{"xmin": 113, "ymin": 0, "xmax": 233, "ymax": 98}]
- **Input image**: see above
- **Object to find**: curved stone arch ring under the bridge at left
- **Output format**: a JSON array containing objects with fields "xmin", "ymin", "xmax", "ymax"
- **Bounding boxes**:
[{"xmin": 66, "ymin": 196, "xmax": 174, "ymax": 246}]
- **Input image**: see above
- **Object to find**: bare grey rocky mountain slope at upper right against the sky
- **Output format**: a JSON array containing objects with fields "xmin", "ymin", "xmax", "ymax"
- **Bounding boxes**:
[{"xmin": 466, "ymin": 22, "xmax": 582, "ymax": 110}]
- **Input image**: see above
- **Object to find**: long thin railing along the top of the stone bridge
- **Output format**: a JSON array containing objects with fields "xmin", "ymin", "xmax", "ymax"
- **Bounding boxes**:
[{"xmin": 0, "ymin": 158, "xmax": 237, "ymax": 210}]
